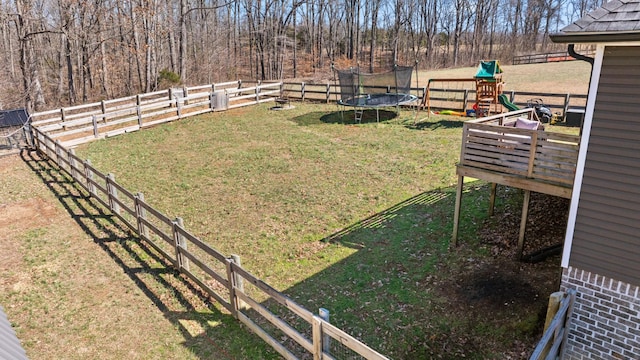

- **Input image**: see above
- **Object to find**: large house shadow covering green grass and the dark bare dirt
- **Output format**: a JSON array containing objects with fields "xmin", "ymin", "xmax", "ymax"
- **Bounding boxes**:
[{"xmin": 276, "ymin": 183, "xmax": 557, "ymax": 359}]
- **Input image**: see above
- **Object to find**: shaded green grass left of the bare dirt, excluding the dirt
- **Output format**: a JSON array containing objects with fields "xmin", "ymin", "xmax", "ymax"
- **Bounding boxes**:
[{"xmin": 274, "ymin": 189, "xmax": 480, "ymax": 359}]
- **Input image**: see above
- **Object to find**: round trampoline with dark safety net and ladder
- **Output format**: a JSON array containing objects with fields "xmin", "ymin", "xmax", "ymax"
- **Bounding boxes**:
[{"xmin": 336, "ymin": 66, "xmax": 418, "ymax": 122}]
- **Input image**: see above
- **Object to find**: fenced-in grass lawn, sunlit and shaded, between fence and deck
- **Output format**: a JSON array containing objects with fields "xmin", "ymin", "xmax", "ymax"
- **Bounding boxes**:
[{"xmin": 70, "ymin": 103, "xmax": 576, "ymax": 358}]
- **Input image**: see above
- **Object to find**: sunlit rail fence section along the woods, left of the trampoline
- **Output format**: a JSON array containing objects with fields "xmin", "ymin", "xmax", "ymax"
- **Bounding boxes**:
[{"xmin": 31, "ymin": 81, "xmax": 281, "ymax": 147}]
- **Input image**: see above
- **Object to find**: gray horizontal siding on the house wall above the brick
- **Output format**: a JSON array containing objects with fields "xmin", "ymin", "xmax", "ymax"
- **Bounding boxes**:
[{"xmin": 569, "ymin": 46, "xmax": 640, "ymax": 285}]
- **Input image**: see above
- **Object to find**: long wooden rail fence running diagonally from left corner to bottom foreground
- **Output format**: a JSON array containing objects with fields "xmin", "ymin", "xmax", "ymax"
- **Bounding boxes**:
[{"xmin": 33, "ymin": 127, "xmax": 387, "ymax": 360}]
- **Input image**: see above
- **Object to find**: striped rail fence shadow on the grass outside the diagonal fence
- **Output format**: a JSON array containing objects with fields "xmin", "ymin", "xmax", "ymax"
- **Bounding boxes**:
[{"xmin": 20, "ymin": 150, "xmax": 277, "ymax": 359}]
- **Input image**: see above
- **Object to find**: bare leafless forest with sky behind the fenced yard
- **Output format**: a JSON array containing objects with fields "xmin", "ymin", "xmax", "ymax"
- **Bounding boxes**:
[{"xmin": 0, "ymin": 0, "xmax": 602, "ymax": 112}]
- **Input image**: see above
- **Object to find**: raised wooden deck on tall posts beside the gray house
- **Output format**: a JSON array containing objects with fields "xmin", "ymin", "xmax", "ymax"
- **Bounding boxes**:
[{"xmin": 452, "ymin": 109, "xmax": 580, "ymax": 257}]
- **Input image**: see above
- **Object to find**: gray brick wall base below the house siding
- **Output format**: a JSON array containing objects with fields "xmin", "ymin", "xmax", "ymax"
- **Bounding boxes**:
[{"xmin": 561, "ymin": 267, "xmax": 640, "ymax": 360}]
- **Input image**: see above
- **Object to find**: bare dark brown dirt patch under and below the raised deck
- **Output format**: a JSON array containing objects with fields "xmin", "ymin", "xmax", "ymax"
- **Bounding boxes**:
[{"xmin": 440, "ymin": 189, "xmax": 568, "ymax": 359}]
